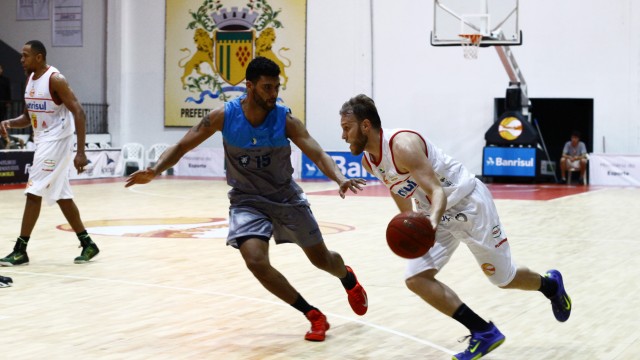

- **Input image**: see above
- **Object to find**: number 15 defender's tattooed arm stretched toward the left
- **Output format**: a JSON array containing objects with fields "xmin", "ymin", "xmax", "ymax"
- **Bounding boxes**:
[{"xmin": 125, "ymin": 107, "xmax": 224, "ymax": 187}]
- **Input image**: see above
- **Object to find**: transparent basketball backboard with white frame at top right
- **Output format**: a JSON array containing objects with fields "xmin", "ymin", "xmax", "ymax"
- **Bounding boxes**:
[{"xmin": 431, "ymin": 0, "xmax": 522, "ymax": 46}]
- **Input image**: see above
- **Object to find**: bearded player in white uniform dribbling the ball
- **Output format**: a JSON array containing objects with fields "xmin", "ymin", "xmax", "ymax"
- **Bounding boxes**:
[{"xmin": 340, "ymin": 95, "xmax": 571, "ymax": 359}]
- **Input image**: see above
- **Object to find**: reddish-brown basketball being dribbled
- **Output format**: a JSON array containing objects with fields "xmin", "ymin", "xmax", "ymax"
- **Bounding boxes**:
[{"xmin": 387, "ymin": 211, "xmax": 435, "ymax": 259}]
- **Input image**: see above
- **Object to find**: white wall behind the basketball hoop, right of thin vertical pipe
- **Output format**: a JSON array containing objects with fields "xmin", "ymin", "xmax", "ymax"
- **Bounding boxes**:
[{"xmin": 373, "ymin": 0, "xmax": 640, "ymax": 173}]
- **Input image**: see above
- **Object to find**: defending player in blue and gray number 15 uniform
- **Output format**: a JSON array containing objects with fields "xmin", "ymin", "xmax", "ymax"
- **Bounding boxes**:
[{"xmin": 126, "ymin": 57, "xmax": 368, "ymax": 341}]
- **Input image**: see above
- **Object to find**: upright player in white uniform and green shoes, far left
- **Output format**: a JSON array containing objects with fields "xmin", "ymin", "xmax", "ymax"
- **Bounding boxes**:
[{"xmin": 0, "ymin": 40, "xmax": 100, "ymax": 266}]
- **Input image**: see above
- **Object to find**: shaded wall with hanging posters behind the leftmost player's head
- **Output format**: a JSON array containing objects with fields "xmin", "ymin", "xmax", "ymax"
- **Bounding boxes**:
[{"xmin": 0, "ymin": 0, "xmax": 106, "ymax": 103}]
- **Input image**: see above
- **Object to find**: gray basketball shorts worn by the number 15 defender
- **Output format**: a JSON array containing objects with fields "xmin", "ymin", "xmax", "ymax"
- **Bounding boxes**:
[{"xmin": 227, "ymin": 198, "xmax": 323, "ymax": 248}]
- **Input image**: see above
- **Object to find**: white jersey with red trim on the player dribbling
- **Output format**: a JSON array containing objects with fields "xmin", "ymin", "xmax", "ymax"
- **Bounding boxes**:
[{"xmin": 364, "ymin": 129, "xmax": 476, "ymax": 211}]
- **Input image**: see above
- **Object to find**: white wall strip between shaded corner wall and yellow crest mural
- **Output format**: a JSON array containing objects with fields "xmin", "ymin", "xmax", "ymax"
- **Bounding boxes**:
[{"xmin": 107, "ymin": 0, "xmax": 192, "ymax": 148}]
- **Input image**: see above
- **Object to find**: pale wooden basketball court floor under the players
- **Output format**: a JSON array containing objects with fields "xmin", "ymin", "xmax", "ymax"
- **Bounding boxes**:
[{"xmin": 0, "ymin": 177, "xmax": 640, "ymax": 360}]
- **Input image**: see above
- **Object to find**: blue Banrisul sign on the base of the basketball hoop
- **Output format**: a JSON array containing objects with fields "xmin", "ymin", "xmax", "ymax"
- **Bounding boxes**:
[{"xmin": 482, "ymin": 146, "xmax": 536, "ymax": 177}]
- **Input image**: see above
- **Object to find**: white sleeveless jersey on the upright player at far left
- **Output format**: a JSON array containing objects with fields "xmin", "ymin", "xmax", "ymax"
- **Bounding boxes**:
[{"xmin": 24, "ymin": 66, "xmax": 75, "ymax": 144}]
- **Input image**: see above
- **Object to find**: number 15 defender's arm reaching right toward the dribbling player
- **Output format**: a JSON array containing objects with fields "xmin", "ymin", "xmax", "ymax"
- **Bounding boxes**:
[{"xmin": 287, "ymin": 115, "xmax": 367, "ymax": 199}]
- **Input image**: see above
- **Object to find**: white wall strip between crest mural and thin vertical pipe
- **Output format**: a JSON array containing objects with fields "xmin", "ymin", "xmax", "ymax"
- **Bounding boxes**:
[{"xmin": 306, "ymin": 0, "xmax": 372, "ymax": 151}]
